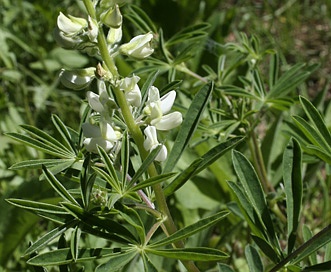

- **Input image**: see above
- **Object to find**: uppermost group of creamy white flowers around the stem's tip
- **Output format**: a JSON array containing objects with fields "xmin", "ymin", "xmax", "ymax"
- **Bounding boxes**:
[{"xmin": 54, "ymin": 4, "xmax": 154, "ymax": 59}]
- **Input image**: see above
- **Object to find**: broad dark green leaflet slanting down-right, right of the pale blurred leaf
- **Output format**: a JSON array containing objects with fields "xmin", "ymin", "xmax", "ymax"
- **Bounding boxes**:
[{"xmin": 232, "ymin": 150, "xmax": 278, "ymax": 246}]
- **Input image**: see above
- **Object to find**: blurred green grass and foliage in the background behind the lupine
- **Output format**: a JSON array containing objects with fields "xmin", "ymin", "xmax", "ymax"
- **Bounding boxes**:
[{"xmin": 0, "ymin": 0, "xmax": 331, "ymax": 271}]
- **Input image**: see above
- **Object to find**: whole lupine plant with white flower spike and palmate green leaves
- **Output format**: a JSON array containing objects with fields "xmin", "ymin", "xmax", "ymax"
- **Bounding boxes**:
[{"xmin": 7, "ymin": 0, "xmax": 331, "ymax": 272}]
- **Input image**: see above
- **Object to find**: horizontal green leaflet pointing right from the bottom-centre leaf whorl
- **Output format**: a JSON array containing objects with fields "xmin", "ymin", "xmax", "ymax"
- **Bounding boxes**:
[{"xmin": 146, "ymin": 247, "xmax": 229, "ymax": 262}]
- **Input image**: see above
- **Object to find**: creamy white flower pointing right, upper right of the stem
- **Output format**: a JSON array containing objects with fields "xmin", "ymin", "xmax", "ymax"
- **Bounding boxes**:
[{"xmin": 120, "ymin": 33, "xmax": 154, "ymax": 59}]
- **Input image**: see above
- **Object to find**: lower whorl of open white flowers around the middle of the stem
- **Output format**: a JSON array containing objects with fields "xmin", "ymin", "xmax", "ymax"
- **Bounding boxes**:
[{"xmin": 83, "ymin": 75, "xmax": 182, "ymax": 162}]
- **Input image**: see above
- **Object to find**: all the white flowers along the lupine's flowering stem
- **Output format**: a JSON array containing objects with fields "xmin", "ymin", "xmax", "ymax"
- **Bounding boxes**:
[{"xmin": 56, "ymin": 1, "xmax": 182, "ymax": 161}]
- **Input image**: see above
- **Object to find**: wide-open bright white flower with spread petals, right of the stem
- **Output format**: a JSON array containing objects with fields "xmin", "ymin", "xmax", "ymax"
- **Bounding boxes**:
[{"xmin": 144, "ymin": 86, "xmax": 183, "ymax": 130}]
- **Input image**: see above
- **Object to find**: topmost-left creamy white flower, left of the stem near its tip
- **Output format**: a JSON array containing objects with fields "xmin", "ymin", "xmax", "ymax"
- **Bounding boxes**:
[{"xmin": 57, "ymin": 12, "xmax": 88, "ymax": 36}]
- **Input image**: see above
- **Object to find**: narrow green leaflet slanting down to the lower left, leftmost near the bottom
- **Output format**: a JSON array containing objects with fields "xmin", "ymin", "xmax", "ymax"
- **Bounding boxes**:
[{"xmin": 23, "ymin": 220, "xmax": 77, "ymax": 256}]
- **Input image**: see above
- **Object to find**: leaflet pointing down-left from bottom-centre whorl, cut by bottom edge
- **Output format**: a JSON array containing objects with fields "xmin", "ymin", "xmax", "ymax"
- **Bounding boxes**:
[{"xmin": 95, "ymin": 250, "xmax": 138, "ymax": 272}]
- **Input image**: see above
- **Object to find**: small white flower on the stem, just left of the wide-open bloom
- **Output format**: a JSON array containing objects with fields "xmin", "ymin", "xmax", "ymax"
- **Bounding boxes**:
[{"xmin": 119, "ymin": 75, "xmax": 141, "ymax": 107}]
